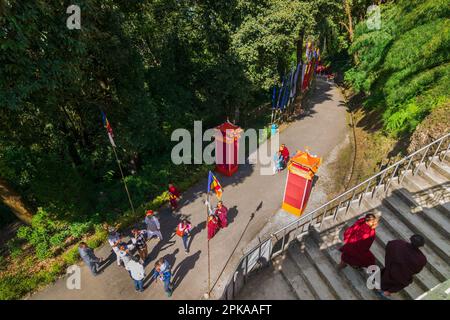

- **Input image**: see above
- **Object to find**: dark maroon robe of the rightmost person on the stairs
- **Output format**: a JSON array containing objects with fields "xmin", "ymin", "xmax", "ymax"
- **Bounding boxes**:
[{"xmin": 381, "ymin": 240, "xmax": 427, "ymax": 293}]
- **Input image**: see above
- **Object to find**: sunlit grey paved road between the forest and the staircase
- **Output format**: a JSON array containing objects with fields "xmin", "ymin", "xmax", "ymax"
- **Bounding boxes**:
[{"xmin": 30, "ymin": 79, "xmax": 348, "ymax": 299}]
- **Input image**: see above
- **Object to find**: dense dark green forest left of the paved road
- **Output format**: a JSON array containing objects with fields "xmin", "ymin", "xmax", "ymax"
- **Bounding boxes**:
[{"xmin": 0, "ymin": 0, "xmax": 341, "ymax": 258}]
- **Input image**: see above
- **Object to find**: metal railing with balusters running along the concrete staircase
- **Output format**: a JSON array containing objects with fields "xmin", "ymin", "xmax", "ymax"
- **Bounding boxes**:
[{"xmin": 222, "ymin": 133, "xmax": 450, "ymax": 300}]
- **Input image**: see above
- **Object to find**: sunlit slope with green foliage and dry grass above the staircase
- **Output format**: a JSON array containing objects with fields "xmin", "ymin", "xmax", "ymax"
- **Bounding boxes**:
[{"xmin": 336, "ymin": 0, "xmax": 450, "ymax": 190}]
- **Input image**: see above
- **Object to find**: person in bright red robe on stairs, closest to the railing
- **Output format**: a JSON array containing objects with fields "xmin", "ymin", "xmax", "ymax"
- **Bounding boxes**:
[{"xmin": 339, "ymin": 213, "xmax": 378, "ymax": 269}]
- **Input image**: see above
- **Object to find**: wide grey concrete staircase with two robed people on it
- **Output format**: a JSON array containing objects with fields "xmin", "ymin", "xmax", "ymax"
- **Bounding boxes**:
[{"xmin": 268, "ymin": 160, "xmax": 450, "ymax": 300}]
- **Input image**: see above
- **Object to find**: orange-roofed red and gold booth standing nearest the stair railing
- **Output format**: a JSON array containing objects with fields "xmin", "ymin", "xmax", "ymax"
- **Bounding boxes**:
[{"xmin": 281, "ymin": 151, "xmax": 322, "ymax": 216}]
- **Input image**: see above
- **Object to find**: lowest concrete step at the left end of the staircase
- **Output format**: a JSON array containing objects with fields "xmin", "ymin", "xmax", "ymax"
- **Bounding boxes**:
[{"xmin": 275, "ymin": 254, "xmax": 314, "ymax": 300}]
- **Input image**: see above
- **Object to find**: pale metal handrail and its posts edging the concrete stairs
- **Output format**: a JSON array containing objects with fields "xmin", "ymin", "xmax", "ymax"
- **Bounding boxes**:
[{"xmin": 225, "ymin": 132, "xmax": 450, "ymax": 297}]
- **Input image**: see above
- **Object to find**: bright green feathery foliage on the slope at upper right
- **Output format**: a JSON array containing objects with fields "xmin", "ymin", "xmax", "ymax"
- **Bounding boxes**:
[{"xmin": 346, "ymin": 0, "xmax": 450, "ymax": 135}]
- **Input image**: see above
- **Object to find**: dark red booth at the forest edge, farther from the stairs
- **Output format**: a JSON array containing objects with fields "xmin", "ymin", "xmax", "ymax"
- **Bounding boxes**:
[{"xmin": 215, "ymin": 120, "xmax": 242, "ymax": 176}]
